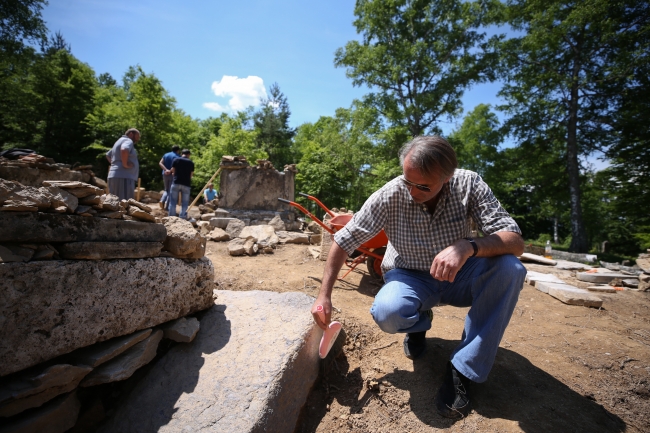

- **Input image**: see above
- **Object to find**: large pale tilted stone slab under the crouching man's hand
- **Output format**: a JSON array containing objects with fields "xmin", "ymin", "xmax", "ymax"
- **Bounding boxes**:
[{"xmin": 99, "ymin": 291, "xmax": 321, "ymax": 433}]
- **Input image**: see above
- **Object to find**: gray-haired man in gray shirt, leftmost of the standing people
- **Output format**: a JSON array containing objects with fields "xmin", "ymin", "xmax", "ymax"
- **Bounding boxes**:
[{"xmin": 106, "ymin": 128, "xmax": 140, "ymax": 200}]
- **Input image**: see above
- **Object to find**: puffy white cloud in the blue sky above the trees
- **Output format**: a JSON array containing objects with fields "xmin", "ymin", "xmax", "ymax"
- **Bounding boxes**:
[{"xmin": 203, "ymin": 75, "xmax": 267, "ymax": 112}]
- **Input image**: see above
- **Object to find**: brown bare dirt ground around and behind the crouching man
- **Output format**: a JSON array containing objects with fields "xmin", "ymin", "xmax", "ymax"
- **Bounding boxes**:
[{"xmin": 207, "ymin": 242, "xmax": 650, "ymax": 433}]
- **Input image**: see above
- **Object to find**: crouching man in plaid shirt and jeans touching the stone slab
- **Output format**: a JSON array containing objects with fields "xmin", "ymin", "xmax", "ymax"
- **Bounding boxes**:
[{"xmin": 311, "ymin": 137, "xmax": 526, "ymax": 418}]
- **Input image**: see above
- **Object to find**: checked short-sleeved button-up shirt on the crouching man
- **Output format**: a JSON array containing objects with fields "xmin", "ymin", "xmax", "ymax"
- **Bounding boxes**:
[{"xmin": 334, "ymin": 169, "xmax": 521, "ymax": 272}]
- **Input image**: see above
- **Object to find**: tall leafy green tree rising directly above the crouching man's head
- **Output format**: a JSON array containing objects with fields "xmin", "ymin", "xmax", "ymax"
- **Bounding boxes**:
[{"xmin": 334, "ymin": 0, "xmax": 500, "ymax": 143}]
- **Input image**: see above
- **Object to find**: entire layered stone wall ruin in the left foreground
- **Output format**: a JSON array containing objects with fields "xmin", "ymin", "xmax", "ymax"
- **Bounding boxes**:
[{"xmin": 0, "ymin": 155, "xmax": 214, "ymax": 433}]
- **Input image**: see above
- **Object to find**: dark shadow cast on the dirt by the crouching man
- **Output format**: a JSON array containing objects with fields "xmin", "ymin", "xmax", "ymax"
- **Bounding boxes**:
[{"xmin": 381, "ymin": 338, "xmax": 625, "ymax": 433}]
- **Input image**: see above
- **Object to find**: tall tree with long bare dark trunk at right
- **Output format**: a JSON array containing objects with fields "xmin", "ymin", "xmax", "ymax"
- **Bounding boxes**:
[{"xmin": 499, "ymin": 0, "xmax": 647, "ymax": 252}]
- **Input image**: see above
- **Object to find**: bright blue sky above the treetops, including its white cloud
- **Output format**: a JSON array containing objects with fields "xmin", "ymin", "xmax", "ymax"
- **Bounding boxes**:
[{"xmin": 43, "ymin": 0, "xmax": 498, "ymax": 132}]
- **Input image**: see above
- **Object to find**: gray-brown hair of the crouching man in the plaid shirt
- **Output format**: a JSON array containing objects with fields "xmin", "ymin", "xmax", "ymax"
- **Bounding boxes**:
[{"xmin": 399, "ymin": 135, "xmax": 458, "ymax": 178}]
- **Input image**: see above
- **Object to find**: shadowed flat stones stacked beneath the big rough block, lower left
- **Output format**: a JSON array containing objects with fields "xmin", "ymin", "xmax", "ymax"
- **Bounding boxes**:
[{"xmin": 0, "ymin": 317, "xmax": 200, "ymax": 433}]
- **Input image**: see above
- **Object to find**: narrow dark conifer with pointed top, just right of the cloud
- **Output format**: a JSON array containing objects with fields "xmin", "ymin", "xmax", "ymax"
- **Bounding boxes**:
[{"xmin": 254, "ymin": 83, "xmax": 296, "ymax": 170}]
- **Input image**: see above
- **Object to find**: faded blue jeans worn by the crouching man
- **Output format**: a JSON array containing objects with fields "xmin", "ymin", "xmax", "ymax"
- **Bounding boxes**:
[{"xmin": 370, "ymin": 255, "xmax": 526, "ymax": 382}]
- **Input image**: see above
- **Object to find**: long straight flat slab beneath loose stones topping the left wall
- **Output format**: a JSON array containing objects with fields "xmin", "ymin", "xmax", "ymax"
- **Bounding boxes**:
[{"xmin": 0, "ymin": 212, "xmax": 167, "ymax": 243}]
